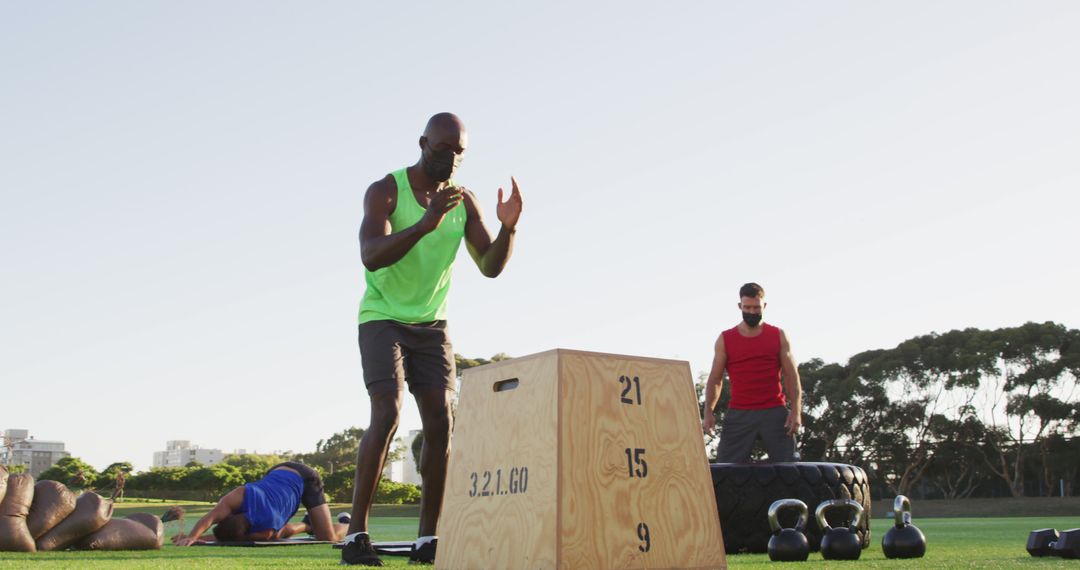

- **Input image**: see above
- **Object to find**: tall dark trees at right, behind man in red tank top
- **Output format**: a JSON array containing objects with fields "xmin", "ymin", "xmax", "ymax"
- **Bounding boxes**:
[{"xmin": 699, "ymin": 322, "xmax": 1080, "ymax": 499}]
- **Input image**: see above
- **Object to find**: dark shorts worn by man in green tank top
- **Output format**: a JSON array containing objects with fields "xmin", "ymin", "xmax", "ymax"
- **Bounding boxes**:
[{"xmin": 357, "ymin": 321, "xmax": 456, "ymax": 394}]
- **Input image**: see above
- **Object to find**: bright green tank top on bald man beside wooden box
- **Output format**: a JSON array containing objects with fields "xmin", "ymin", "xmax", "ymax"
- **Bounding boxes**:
[{"xmin": 357, "ymin": 168, "xmax": 465, "ymax": 323}]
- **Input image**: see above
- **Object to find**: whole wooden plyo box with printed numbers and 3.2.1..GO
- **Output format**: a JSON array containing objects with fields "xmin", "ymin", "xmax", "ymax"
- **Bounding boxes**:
[{"xmin": 435, "ymin": 349, "xmax": 727, "ymax": 569}]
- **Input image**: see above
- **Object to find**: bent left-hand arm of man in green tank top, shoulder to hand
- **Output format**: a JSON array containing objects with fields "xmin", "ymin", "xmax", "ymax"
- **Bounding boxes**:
[{"xmin": 360, "ymin": 175, "xmax": 461, "ymax": 271}]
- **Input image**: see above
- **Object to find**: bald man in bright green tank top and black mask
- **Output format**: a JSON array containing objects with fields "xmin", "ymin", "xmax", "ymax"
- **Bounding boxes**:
[{"xmin": 341, "ymin": 113, "xmax": 522, "ymax": 566}]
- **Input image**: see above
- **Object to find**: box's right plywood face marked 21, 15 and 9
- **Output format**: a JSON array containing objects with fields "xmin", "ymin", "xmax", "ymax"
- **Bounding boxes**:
[{"xmin": 559, "ymin": 351, "xmax": 725, "ymax": 568}]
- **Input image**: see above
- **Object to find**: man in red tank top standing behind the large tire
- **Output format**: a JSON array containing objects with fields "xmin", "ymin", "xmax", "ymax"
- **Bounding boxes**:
[{"xmin": 702, "ymin": 283, "xmax": 802, "ymax": 463}]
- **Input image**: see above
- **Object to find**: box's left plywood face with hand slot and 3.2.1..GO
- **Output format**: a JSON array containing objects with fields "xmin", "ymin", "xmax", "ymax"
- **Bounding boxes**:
[{"xmin": 435, "ymin": 352, "xmax": 558, "ymax": 569}]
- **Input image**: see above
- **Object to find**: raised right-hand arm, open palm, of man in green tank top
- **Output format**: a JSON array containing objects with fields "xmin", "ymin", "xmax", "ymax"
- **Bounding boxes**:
[{"xmin": 465, "ymin": 177, "xmax": 522, "ymax": 277}]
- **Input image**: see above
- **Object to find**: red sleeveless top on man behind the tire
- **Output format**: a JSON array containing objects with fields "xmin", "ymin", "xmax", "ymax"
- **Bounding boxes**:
[{"xmin": 723, "ymin": 324, "xmax": 787, "ymax": 409}]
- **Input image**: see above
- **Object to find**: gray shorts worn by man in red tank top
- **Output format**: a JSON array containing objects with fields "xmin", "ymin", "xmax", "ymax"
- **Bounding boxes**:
[{"xmin": 716, "ymin": 406, "xmax": 797, "ymax": 463}]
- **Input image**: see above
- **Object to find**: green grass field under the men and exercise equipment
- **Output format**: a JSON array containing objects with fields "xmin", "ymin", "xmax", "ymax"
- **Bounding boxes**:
[{"xmin": 0, "ymin": 502, "xmax": 1080, "ymax": 569}]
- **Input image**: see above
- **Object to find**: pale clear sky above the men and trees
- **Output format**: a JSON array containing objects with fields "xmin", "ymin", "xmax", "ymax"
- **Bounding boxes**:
[{"xmin": 0, "ymin": 0, "xmax": 1080, "ymax": 469}]
